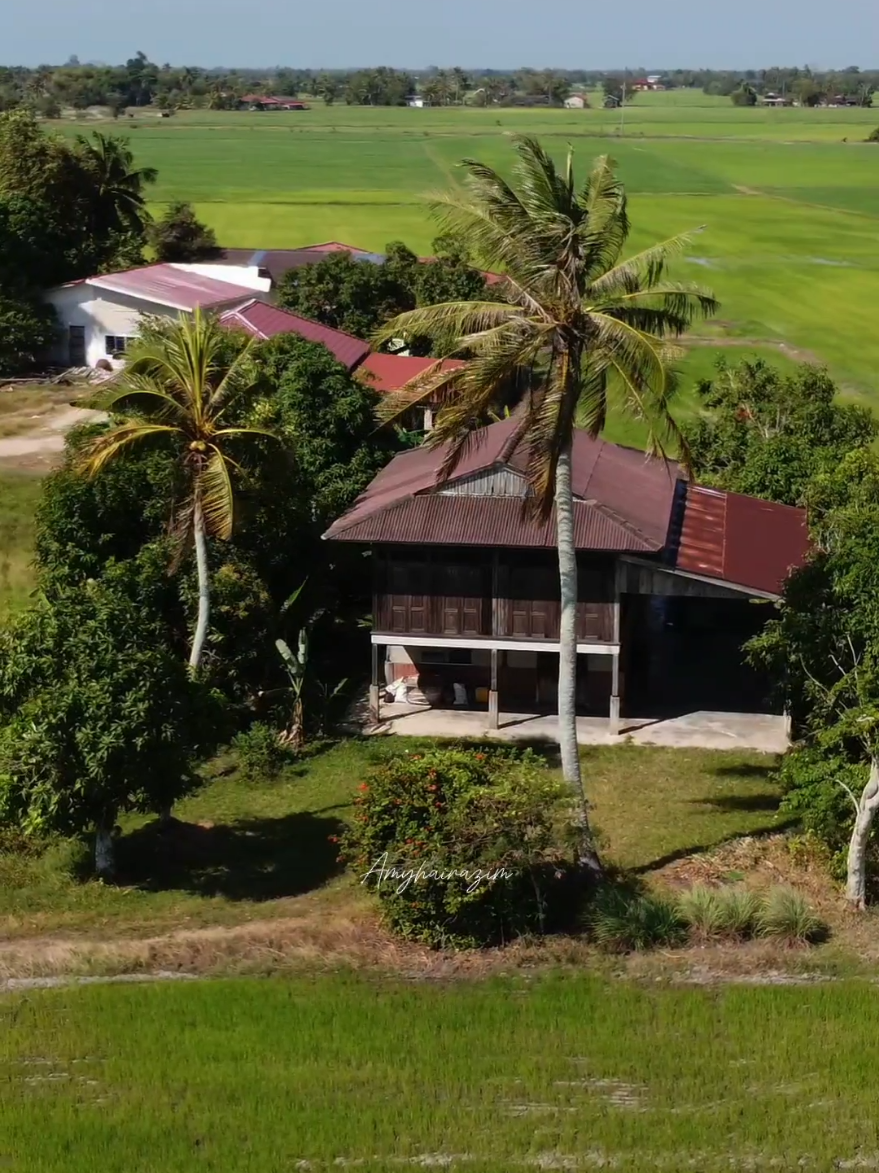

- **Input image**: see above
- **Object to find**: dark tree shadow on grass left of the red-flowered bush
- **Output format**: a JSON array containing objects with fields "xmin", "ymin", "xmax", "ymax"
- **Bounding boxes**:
[{"xmin": 109, "ymin": 812, "xmax": 344, "ymax": 901}]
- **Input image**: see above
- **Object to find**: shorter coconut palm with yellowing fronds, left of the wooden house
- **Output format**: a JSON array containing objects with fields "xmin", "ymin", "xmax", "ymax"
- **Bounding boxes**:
[{"xmin": 79, "ymin": 310, "xmax": 276, "ymax": 672}]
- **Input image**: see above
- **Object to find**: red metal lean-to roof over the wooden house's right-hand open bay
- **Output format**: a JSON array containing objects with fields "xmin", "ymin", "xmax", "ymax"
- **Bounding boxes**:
[{"xmin": 675, "ymin": 484, "xmax": 809, "ymax": 595}]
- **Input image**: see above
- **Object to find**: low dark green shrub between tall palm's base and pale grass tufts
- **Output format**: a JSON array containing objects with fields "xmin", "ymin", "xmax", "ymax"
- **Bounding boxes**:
[{"xmin": 586, "ymin": 884, "xmax": 687, "ymax": 952}]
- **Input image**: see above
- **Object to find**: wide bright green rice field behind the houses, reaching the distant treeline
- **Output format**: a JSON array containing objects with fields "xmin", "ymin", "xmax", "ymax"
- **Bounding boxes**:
[{"xmin": 53, "ymin": 91, "xmax": 879, "ymax": 402}]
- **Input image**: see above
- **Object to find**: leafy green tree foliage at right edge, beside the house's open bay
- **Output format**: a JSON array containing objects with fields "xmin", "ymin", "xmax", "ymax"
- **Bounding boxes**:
[{"xmin": 749, "ymin": 448, "xmax": 879, "ymax": 869}]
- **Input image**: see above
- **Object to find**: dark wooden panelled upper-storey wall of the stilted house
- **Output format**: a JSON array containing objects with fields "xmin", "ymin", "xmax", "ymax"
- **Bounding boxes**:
[{"xmin": 374, "ymin": 547, "xmax": 614, "ymax": 643}]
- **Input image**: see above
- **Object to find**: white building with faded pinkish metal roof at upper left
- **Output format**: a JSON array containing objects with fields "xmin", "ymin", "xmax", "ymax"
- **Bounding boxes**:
[{"xmin": 46, "ymin": 264, "xmax": 271, "ymax": 367}]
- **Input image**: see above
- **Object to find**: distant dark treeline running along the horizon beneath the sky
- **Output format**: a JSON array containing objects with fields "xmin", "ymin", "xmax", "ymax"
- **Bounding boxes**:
[{"xmin": 0, "ymin": 53, "xmax": 879, "ymax": 117}]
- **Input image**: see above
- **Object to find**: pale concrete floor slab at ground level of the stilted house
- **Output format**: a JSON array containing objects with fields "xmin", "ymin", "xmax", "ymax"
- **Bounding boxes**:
[{"xmin": 368, "ymin": 704, "xmax": 789, "ymax": 753}]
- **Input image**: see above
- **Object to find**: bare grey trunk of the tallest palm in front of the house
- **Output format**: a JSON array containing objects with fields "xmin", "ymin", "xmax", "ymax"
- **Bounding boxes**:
[{"xmin": 555, "ymin": 443, "xmax": 602, "ymax": 875}]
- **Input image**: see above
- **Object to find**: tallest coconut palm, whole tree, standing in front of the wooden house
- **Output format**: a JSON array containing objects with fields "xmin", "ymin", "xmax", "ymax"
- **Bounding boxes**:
[{"xmin": 378, "ymin": 137, "xmax": 716, "ymax": 868}]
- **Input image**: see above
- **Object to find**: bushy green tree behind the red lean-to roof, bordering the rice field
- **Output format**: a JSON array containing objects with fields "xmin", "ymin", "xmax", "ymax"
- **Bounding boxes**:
[{"xmin": 684, "ymin": 359, "xmax": 879, "ymax": 504}]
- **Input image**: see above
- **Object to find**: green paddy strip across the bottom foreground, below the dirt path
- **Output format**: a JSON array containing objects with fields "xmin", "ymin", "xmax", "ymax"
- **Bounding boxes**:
[{"xmin": 0, "ymin": 974, "xmax": 879, "ymax": 1173}]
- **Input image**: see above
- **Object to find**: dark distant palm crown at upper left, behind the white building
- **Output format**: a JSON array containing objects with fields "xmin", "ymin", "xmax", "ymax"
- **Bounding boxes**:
[{"xmin": 76, "ymin": 130, "xmax": 158, "ymax": 232}]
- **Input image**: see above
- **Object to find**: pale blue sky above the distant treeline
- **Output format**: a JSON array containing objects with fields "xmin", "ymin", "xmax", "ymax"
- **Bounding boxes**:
[{"xmin": 0, "ymin": 0, "xmax": 879, "ymax": 69}]
